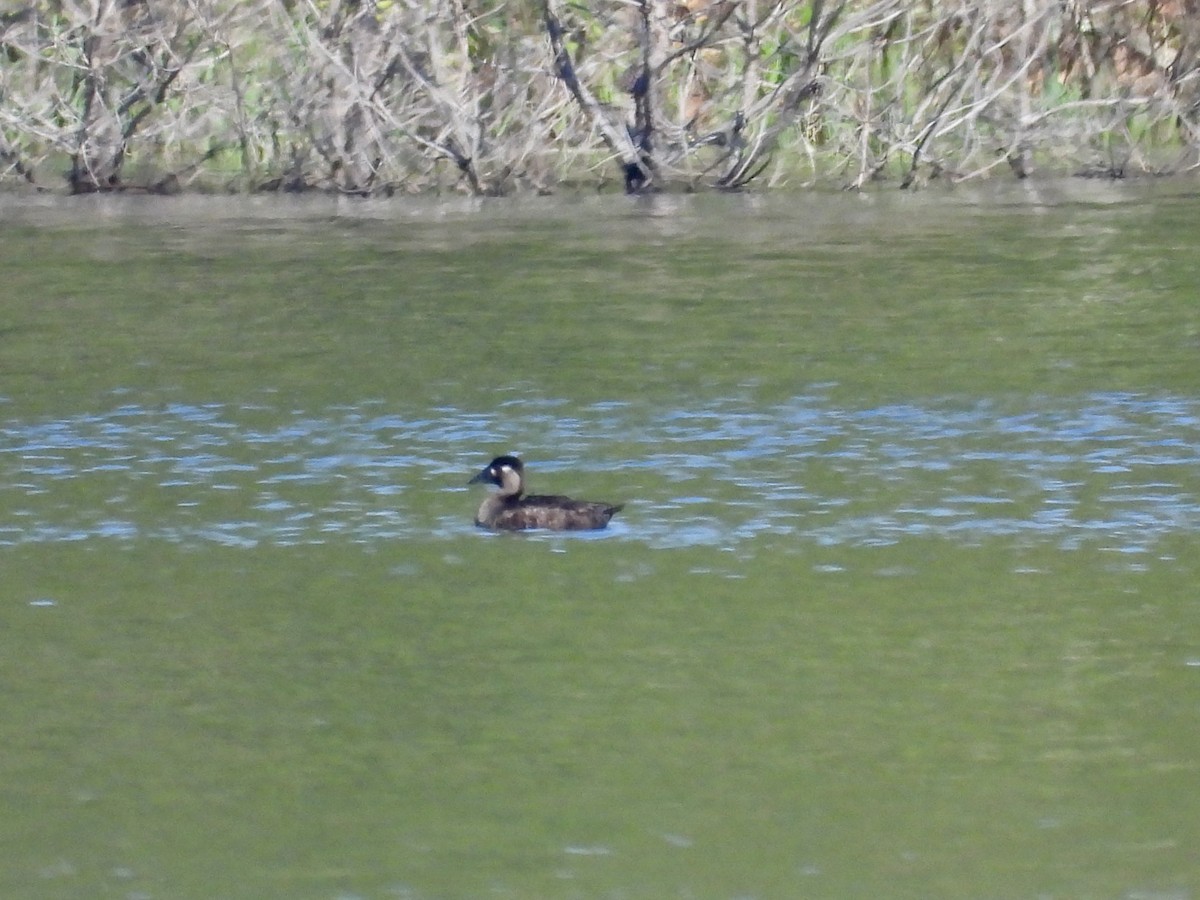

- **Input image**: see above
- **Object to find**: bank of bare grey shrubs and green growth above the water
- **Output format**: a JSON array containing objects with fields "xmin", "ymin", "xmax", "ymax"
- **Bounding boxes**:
[{"xmin": 0, "ymin": 0, "xmax": 1200, "ymax": 196}]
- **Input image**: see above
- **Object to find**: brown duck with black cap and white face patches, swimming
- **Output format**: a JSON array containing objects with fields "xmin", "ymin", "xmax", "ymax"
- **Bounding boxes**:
[{"xmin": 467, "ymin": 456, "xmax": 625, "ymax": 532}]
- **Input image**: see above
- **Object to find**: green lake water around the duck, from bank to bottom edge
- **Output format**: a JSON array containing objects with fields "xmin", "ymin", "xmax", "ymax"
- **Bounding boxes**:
[{"xmin": 0, "ymin": 184, "xmax": 1200, "ymax": 899}]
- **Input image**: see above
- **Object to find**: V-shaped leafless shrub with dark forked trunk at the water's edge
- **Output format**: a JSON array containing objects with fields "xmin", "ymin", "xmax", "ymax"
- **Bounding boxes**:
[{"xmin": 545, "ymin": 0, "xmax": 847, "ymax": 191}]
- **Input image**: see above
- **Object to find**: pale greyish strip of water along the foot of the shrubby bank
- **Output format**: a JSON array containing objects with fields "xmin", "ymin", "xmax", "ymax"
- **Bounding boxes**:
[{"xmin": 0, "ymin": 172, "xmax": 1200, "ymax": 224}]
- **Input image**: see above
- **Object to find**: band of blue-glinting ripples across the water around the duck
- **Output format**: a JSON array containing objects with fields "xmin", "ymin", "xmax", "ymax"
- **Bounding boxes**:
[{"xmin": 0, "ymin": 392, "xmax": 1200, "ymax": 552}]
